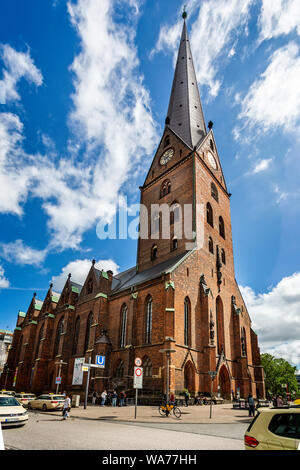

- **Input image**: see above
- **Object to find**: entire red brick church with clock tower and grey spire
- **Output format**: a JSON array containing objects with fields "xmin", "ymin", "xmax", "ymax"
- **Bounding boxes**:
[{"xmin": 0, "ymin": 14, "xmax": 265, "ymax": 399}]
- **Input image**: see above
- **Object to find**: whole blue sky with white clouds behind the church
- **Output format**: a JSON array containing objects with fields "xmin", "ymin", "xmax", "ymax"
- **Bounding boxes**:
[{"xmin": 0, "ymin": 0, "xmax": 300, "ymax": 368}]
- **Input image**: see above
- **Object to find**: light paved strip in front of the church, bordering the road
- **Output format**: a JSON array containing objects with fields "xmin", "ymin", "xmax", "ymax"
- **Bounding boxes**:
[{"xmin": 42, "ymin": 404, "xmax": 252, "ymax": 424}]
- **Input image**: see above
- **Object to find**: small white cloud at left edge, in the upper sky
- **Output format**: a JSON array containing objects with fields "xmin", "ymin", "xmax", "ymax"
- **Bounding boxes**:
[{"xmin": 0, "ymin": 44, "xmax": 43, "ymax": 103}]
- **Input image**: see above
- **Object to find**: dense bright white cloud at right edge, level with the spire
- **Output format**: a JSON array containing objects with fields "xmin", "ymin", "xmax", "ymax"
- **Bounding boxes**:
[{"xmin": 234, "ymin": 42, "xmax": 300, "ymax": 138}]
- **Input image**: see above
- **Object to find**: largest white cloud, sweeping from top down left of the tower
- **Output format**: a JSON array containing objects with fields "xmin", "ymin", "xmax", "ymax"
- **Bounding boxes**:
[{"xmin": 0, "ymin": 0, "xmax": 158, "ymax": 253}]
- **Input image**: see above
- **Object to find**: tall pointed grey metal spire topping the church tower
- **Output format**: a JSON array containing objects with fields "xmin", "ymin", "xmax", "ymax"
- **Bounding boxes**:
[{"xmin": 166, "ymin": 11, "xmax": 207, "ymax": 149}]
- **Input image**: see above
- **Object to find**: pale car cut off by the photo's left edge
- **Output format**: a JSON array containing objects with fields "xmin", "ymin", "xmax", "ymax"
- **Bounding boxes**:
[{"xmin": 0, "ymin": 393, "xmax": 28, "ymax": 427}]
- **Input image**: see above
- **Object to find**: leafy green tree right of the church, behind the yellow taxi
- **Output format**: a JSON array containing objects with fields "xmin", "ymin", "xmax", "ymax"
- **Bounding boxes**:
[{"xmin": 261, "ymin": 353, "xmax": 298, "ymax": 395}]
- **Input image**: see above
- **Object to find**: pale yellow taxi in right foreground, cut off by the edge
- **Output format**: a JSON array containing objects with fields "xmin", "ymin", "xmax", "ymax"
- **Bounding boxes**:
[{"xmin": 244, "ymin": 405, "xmax": 300, "ymax": 450}]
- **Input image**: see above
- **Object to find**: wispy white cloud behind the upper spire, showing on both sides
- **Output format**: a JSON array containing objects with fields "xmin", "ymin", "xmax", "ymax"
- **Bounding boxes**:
[{"xmin": 151, "ymin": 0, "xmax": 253, "ymax": 96}]
